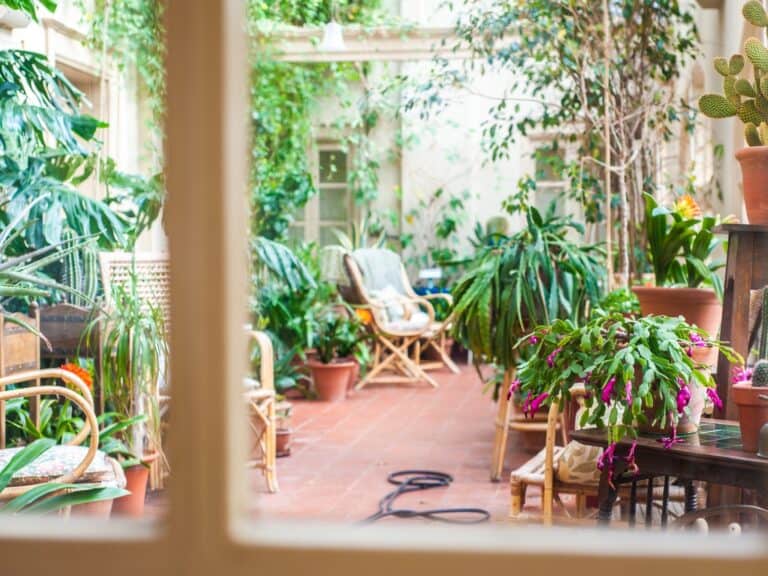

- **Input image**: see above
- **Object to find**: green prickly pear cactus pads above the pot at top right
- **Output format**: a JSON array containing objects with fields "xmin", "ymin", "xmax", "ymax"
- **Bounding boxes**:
[{"xmin": 699, "ymin": 0, "xmax": 768, "ymax": 146}]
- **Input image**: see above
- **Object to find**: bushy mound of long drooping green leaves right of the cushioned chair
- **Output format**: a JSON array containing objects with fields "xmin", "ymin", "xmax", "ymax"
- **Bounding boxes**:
[{"xmin": 453, "ymin": 208, "xmax": 605, "ymax": 368}]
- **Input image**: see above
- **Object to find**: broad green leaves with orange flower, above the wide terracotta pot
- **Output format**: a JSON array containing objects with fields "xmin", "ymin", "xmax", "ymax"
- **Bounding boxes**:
[{"xmin": 645, "ymin": 194, "xmax": 725, "ymax": 297}]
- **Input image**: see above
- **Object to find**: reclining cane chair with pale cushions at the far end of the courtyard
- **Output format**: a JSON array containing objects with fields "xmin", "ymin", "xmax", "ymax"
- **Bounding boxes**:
[{"xmin": 344, "ymin": 248, "xmax": 459, "ymax": 390}]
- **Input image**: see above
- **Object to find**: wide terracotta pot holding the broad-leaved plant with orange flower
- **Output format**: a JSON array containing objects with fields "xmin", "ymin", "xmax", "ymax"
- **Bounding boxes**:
[{"xmin": 632, "ymin": 286, "xmax": 723, "ymax": 337}]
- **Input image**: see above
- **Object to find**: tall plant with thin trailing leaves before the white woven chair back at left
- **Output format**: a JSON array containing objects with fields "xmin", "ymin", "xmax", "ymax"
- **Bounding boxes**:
[{"xmin": 86, "ymin": 272, "xmax": 169, "ymax": 515}]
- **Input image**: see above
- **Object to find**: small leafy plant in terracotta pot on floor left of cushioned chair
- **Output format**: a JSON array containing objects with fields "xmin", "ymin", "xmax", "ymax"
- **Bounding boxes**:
[{"xmin": 307, "ymin": 309, "xmax": 355, "ymax": 402}]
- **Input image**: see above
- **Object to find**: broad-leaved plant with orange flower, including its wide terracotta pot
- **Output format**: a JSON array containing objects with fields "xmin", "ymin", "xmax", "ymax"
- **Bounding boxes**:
[{"xmin": 632, "ymin": 194, "xmax": 725, "ymax": 336}]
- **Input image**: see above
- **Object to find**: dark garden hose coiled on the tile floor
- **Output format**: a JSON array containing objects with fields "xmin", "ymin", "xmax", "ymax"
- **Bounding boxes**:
[{"xmin": 363, "ymin": 470, "xmax": 491, "ymax": 524}]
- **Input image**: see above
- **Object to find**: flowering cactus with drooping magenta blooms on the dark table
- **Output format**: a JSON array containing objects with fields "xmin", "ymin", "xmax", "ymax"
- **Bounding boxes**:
[{"xmin": 512, "ymin": 309, "xmax": 738, "ymax": 472}]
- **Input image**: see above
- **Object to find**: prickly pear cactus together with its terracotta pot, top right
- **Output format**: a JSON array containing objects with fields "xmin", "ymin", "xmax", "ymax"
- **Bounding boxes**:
[{"xmin": 699, "ymin": 0, "xmax": 768, "ymax": 225}]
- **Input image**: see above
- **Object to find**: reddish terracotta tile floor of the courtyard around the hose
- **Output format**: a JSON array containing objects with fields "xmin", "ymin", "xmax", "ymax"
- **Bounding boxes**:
[{"xmin": 252, "ymin": 366, "xmax": 538, "ymax": 522}]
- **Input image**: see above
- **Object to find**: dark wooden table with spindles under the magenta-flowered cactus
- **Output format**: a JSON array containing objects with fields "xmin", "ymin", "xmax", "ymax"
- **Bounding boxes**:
[{"xmin": 571, "ymin": 420, "xmax": 768, "ymax": 524}]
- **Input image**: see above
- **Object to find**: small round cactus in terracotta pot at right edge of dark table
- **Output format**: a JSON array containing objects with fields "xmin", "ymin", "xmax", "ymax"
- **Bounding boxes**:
[{"xmin": 731, "ymin": 287, "xmax": 768, "ymax": 452}]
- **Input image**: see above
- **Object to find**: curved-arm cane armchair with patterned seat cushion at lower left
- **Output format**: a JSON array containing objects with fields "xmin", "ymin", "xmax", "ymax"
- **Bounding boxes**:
[{"xmin": 0, "ymin": 369, "xmax": 126, "ymax": 501}]
